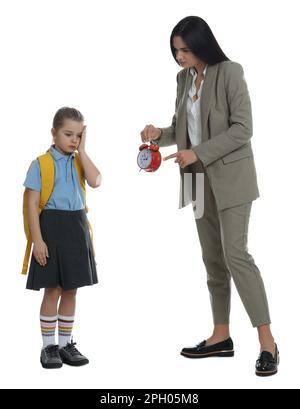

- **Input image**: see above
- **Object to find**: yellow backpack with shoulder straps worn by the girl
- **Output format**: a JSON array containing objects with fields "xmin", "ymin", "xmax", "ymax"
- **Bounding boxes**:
[{"xmin": 22, "ymin": 151, "xmax": 95, "ymax": 274}]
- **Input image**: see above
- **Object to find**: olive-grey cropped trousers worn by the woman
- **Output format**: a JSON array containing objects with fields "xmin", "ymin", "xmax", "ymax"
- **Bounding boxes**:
[{"xmin": 190, "ymin": 162, "xmax": 271, "ymax": 327}]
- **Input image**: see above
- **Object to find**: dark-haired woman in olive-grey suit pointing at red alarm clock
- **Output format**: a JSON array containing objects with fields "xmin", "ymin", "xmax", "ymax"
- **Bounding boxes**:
[{"xmin": 141, "ymin": 16, "xmax": 279, "ymax": 376}]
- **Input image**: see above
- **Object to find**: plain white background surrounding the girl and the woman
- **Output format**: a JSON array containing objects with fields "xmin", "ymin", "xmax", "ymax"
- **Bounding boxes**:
[{"xmin": 0, "ymin": 0, "xmax": 300, "ymax": 388}]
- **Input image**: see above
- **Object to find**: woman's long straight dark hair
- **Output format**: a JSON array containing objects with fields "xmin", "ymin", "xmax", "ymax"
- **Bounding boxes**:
[{"xmin": 170, "ymin": 16, "xmax": 229, "ymax": 65}]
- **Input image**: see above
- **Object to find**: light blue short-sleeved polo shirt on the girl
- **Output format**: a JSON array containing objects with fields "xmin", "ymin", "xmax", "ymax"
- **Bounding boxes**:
[{"xmin": 23, "ymin": 145, "xmax": 85, "ymax": 210}]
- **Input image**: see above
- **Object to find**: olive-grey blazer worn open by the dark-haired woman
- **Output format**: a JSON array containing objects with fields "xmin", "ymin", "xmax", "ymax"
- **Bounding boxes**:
[{"xmin": 157, "ymin": 61, "xmax": 259, "ymax": 210}]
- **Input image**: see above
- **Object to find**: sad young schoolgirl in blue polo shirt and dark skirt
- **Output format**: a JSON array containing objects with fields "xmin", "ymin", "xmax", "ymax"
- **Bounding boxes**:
[{"xmin": 24, "ymin": 107, "xmax": 101, "ymax": 368}]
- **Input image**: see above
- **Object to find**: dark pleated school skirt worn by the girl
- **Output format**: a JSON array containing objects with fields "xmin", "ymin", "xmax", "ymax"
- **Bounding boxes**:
[{"xmin": 26, "ymin": 209, "xmax": 98, "ymax": 290}]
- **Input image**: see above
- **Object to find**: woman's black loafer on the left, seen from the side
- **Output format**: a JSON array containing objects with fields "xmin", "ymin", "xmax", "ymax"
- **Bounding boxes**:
[{"xmin": 181, "ymin": 338, "xmax": 234, "ymax": 358}]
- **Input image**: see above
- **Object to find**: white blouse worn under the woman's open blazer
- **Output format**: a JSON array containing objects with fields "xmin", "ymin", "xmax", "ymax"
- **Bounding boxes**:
[{"xmin": 186, "ymin": 66, "xmax": 207, "ymax": 147}]
